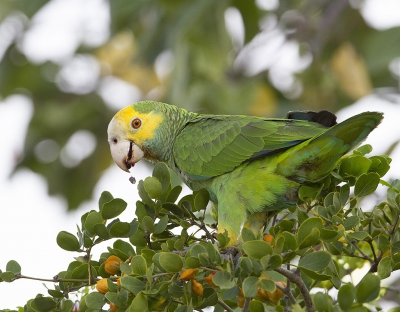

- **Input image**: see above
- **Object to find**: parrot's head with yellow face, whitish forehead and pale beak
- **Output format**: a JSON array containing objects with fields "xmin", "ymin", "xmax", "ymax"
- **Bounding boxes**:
[{"xmin": 107, "ymin": 102, "xmax": 165, "ymax": 172}]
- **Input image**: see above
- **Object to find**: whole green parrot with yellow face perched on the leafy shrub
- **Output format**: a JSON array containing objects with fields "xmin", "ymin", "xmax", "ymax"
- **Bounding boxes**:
[{"xmin": 108, "ymin": 101, "xmax": 383, "ymax": 246}]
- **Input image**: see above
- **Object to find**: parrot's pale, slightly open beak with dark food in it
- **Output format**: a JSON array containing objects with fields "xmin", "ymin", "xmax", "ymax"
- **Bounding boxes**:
[{"xmin": 110, "ymin": 141, "xmax": 144, "ymax": 172}]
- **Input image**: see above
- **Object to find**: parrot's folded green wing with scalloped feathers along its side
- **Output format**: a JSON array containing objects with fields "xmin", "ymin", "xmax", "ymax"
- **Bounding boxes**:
[{"xmin": 173, "ymin": 115, "xmax": 327, "ymax": 180}]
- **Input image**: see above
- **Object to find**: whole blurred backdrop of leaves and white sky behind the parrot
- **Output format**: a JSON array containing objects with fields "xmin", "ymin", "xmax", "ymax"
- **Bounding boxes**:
[{"xmin": 0, "ymin": 0, "xmax": 400, "ymax": 309}]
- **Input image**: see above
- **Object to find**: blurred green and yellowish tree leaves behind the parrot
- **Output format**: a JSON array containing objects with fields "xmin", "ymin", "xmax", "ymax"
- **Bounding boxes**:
[{"xmin": 0, "ymin": 0, "xmax": 400, "ymax": 209}]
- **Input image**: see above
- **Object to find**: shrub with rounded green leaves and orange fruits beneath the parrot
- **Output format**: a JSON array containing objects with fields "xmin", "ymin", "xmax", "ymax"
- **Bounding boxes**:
[{"xmin": 0, "ymin": 146, "xmax": 400, "ymax": 311}]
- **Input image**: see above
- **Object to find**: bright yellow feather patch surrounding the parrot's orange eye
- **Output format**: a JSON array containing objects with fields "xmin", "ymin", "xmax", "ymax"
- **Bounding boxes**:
[{"xmin": 114, "ymin": 106, "xmax": 163, "ymax": 145}]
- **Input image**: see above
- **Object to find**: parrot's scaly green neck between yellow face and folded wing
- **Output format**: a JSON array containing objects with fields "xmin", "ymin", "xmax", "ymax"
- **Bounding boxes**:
[{"xmin": 145, "ymin": 105, "xmax": 198, "ymax": 169}]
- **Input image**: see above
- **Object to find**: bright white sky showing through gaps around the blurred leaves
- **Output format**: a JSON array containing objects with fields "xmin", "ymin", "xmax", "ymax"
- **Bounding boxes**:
[{"xmin": 0, "ymin": 0, "xmax": 400, "ymax": 309}]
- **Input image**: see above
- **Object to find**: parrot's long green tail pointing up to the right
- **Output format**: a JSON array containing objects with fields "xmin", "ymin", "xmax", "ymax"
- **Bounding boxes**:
[{"xmin": 278, "ymin": 112, "xmax": 383, "ymax": 183}]
